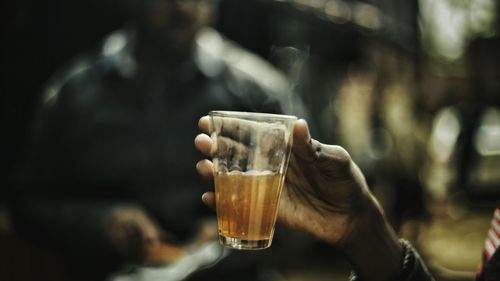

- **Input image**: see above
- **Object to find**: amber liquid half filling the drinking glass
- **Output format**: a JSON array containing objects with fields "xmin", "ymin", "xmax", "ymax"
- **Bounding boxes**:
[{"xmin": 215, "ymin": 172, "xmax": 283, "ymax": 244}]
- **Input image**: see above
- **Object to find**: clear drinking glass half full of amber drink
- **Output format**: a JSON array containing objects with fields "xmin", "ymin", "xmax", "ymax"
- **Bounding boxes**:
[{"xmin": 209, "ymin": 111, "xmax": 297, "ymax": 250}]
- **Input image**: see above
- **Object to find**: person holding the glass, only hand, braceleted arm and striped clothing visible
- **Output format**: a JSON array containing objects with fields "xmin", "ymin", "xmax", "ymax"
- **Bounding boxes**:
[{"xmin": 195, "ymin": 117, "xmax": 500, "ymax": 281}]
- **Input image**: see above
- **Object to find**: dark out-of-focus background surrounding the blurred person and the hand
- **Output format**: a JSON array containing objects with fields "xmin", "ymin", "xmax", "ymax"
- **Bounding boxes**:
[{"xmin": 0, "ymin": 0, "xmax": 500, "ymax": 280}]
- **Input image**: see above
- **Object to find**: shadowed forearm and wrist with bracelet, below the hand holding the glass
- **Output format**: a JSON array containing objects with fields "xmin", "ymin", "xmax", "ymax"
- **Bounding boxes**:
[{"xmin": 339, "ymin": 184, "xmax": 434, "ymax": 281}]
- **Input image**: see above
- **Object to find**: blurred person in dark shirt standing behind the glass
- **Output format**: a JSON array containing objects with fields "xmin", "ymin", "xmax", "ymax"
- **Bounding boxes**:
[{"xmin": 11, "ymin": 0, "xmax": 305, "ymax": 280}]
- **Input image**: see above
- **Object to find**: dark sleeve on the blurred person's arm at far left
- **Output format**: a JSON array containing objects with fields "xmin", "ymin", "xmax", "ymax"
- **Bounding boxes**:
[{"xmin": 10, "ymin": 68, "xmax": 121, "ymax": 262}]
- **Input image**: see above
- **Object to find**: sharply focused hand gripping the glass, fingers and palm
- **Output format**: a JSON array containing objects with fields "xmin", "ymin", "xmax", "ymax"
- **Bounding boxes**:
[{"xmin": 195, "ymin": 117, "xmax": 375, "ymax": 245}]
